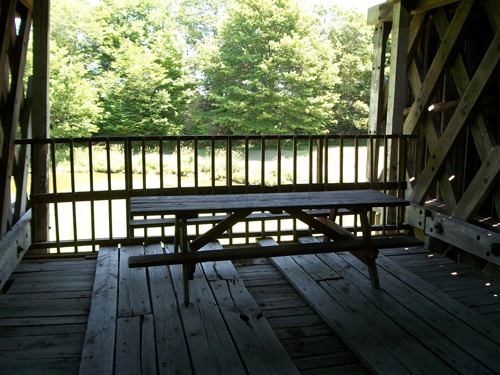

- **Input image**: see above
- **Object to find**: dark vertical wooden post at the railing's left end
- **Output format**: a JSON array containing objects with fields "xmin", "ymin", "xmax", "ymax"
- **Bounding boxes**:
[{"xmin": 32, "ymin": 0, "xmax": 50, "ymax": 242}]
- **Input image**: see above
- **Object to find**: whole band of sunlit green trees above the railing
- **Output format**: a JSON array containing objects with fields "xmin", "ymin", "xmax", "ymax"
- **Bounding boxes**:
[{"xmin": 50, "ymin": 0, "xmax": 371, "ymax": 137}]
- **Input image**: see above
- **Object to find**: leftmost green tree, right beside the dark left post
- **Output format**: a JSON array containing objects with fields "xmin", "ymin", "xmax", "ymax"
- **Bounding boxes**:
[{"xmin": 49, "ymin": 0, "xmax": 102, "ymax": 137}]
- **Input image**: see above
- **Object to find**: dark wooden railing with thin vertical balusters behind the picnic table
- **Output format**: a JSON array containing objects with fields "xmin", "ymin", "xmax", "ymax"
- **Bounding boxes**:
[{"xmin": 13, "ymin": 135, "xmax": 416, "ymax": 254}]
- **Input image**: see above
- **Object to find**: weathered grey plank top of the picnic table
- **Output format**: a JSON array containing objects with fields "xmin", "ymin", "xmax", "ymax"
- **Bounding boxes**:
[{"xmin": 130, "ymin": 190, "xmax": 409, "ymax": 215}]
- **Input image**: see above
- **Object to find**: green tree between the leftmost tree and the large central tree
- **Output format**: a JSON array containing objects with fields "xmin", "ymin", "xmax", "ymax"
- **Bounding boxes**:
[{"xmin": 96, "ymin": 0, "xmax": 195, "ymax": 135}]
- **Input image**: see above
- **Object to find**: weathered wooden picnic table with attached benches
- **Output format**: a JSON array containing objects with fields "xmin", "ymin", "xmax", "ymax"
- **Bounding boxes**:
[{"xmin": 129, "ymin": 190, "xmax": 415, "ymax": 304}]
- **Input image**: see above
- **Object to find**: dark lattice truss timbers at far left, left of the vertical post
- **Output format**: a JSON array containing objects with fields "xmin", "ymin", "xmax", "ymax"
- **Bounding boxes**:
[{"xmin": 0, "ymin": 0, "xmax": 32, "ymax": 236}]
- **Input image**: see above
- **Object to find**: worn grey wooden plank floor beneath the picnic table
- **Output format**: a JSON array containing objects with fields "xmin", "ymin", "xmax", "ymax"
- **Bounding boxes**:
[{"xmin": 0, "ymin": 239, "xmax": 500, "ymax": 375}]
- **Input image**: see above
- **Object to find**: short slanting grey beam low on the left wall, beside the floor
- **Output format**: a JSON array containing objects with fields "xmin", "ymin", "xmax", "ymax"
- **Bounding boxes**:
[{"xmin": 0, "ymin": 210, "xmax": 31, "ymax": 289}]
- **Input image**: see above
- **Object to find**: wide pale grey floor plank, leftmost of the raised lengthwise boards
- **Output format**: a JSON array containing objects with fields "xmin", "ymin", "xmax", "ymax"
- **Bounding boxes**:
[{"xmin": 79, "ymin": 247, "xmax": 118, "ymax": 375}]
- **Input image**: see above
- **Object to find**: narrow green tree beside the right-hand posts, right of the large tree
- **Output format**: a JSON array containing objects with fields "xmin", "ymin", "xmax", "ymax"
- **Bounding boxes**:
[{"xmin": 316, "ymin": 6, "xmax": 373, "ymax": 134}]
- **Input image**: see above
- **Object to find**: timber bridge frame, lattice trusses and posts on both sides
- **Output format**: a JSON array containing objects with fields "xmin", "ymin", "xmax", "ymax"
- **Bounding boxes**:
[{"xmin": 0, "ymin": 0, "xmax": 500, "ymax": 276}]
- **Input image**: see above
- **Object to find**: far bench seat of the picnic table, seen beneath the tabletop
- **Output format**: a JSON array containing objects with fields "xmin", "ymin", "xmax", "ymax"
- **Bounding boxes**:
[{"xmin": 130, "ymin": 209, "xmax": 354, "ymax": 229}]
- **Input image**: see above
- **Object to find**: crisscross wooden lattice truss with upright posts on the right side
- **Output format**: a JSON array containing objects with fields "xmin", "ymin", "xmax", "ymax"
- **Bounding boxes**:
[{"xmin": 368, "ymin": 0, "xmax": 500, "ymax": 264}]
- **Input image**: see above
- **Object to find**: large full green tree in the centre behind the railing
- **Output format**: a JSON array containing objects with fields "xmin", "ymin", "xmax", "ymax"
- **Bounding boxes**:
[{"xmin": 197, "ymin": 0, "xmax": 337, "ymax": 134}]
